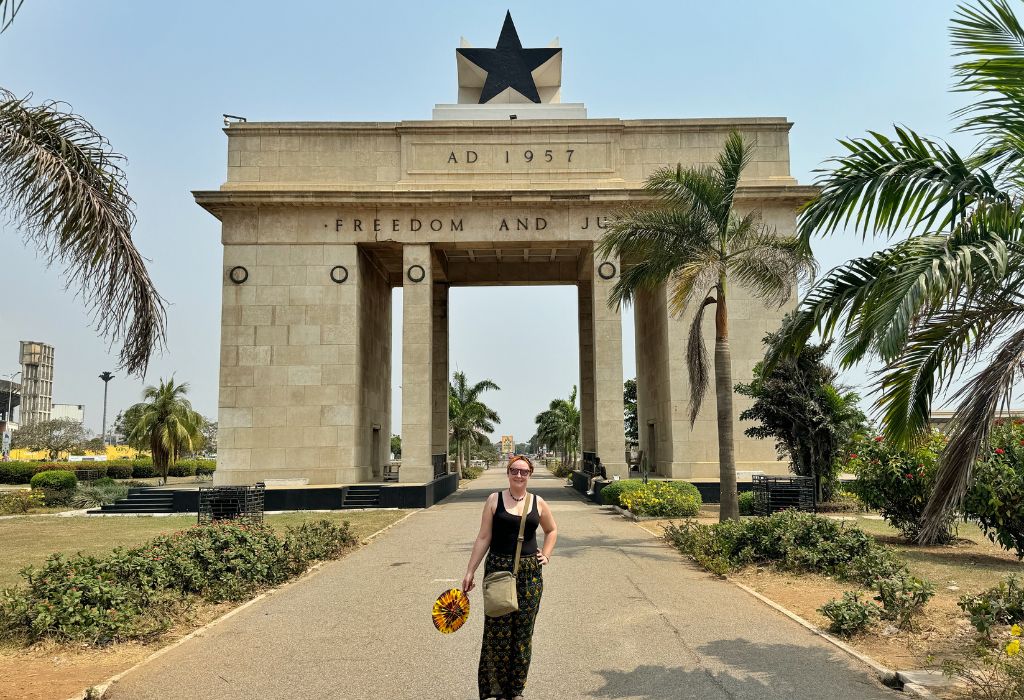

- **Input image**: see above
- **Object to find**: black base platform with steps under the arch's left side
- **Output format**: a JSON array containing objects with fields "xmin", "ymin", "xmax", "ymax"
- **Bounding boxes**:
[{"xmin": 89, "ymin": 474, "xmax": 459, "ymax": 514}]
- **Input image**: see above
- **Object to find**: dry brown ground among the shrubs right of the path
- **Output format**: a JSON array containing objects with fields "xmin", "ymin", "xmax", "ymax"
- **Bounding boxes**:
[{"xmin": 642, "ymin": 513, "xmax": 1024, "ymax": 670}]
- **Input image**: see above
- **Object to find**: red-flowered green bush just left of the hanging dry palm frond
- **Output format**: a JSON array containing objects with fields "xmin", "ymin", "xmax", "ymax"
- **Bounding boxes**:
[{"xmin": 848, "ymin": 431, "xmax": 954, "ymax": 542}]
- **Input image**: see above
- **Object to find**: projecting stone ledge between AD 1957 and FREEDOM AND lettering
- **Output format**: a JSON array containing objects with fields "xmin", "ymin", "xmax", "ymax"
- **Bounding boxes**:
[{"xmin": 193, "ymin": 184, "xmax": 818, "ymax": 216}]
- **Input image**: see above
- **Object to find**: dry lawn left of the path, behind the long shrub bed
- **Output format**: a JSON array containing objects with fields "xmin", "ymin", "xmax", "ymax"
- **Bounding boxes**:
[{"xmin": 0, "ymin": 510, "xmax": 409, "ymax": 588}]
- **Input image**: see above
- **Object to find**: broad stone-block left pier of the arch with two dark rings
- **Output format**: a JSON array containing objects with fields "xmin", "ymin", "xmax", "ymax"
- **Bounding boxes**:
[{"xmin": 215, "ymin": 237, "xmax": 360, "ymax": 484}]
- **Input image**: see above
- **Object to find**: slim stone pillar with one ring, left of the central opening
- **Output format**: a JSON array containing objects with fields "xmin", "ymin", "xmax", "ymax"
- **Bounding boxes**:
[{"xmin": 398, "ymin": 245, "xmax": 434, "ymax": 483}]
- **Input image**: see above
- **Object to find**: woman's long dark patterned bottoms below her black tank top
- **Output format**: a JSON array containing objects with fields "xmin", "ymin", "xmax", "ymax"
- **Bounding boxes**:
[{"xmin": 477, "ymin": 554, "xmax": 544, "ymax": 700}]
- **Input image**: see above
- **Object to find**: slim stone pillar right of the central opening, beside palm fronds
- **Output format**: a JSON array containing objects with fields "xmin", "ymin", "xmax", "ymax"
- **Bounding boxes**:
[{"xmin": 591, "ymin": 251, "xmax": 629, "ymax": 478}]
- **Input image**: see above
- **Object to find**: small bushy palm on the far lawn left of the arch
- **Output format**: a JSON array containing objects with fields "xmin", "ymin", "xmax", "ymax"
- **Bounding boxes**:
[{"xmin": 129, "ymin": 377, "xmax": 204, "ymax": 482}]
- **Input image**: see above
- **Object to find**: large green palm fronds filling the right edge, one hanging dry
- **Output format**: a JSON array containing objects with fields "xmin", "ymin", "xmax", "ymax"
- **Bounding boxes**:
[{"xmin": 770, "ymin": 0, "xmax": 1024, "ymax": 542}]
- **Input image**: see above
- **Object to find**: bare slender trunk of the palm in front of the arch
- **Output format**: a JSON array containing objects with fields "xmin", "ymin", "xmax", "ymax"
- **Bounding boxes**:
[{"xmin": 715, "ymin": 282, "xmax": 739, "ymax": 522}]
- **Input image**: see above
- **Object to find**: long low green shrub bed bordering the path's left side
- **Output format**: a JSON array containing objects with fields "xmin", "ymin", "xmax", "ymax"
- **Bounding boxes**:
[{"xmin": 0, "ymin": 521, "xmax": 354, "ymax": 645}]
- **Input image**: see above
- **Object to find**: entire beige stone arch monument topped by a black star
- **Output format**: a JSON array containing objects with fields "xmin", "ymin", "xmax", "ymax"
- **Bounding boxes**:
[{"xmin": 195, "ymin": 16, "xmax": 813, "ymax": 485}]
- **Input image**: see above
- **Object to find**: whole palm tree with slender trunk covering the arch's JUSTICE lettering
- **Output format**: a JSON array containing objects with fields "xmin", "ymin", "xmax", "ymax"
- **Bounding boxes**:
[{"xmin": 597, "ymin": 132, "xmax": 813, "ymax": 521}]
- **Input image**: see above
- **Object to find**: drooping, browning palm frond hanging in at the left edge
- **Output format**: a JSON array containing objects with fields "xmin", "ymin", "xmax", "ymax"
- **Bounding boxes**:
[{"xmin": 0, "ymin": 13, "xmax": 166, "ymax": 376}]
